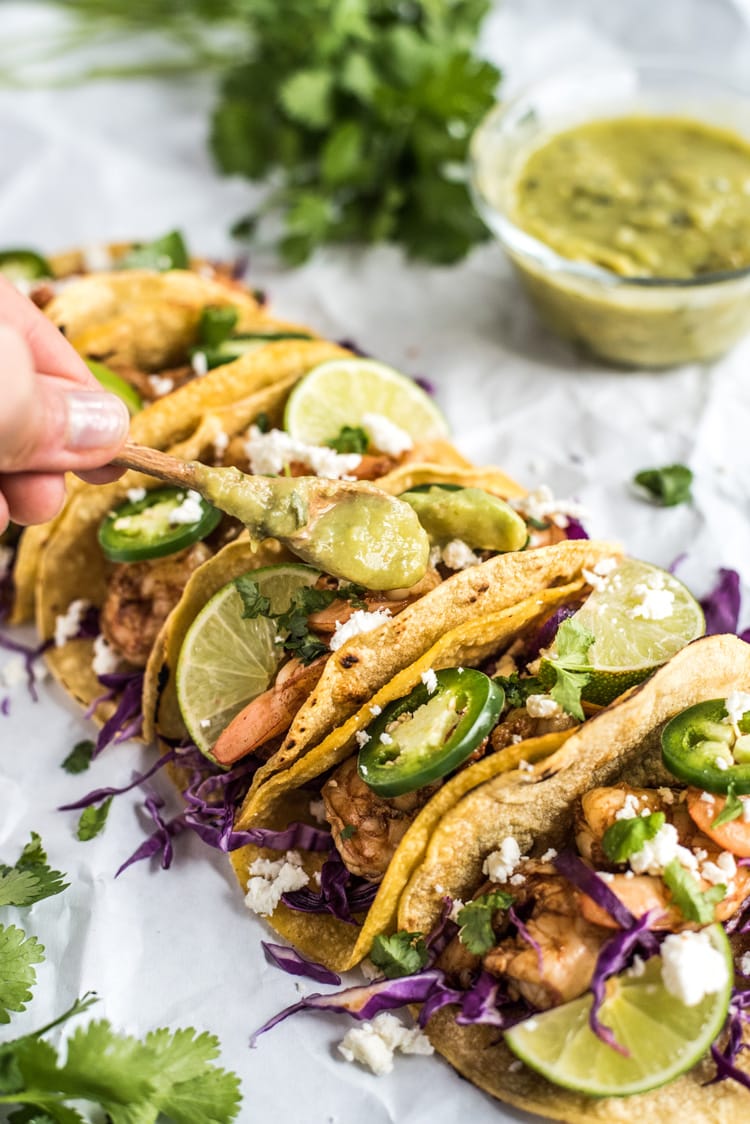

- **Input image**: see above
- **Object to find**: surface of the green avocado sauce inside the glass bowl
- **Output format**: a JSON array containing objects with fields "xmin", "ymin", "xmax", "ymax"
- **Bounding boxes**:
[{"xmin": 513, "ymin": 117, "xmax": 750, "ymax": 279}]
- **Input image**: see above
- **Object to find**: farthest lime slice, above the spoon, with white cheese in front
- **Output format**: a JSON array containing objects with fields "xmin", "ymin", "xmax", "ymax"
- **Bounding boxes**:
[{"xmin": 283, "ymin": 359, "xmax": 449, "ymax": 445}]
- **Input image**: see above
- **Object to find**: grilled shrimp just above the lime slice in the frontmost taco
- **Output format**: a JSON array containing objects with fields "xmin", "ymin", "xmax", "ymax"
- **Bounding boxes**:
[{"xmin": 484, "ymin": 868, "xmax": 611, "ymax": 1010}]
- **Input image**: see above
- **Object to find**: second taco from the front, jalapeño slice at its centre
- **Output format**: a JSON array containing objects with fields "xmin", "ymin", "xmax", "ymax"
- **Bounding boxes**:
[{"xmin": 222, "ymin": 542, "xmax": 715, "ymax": 971}]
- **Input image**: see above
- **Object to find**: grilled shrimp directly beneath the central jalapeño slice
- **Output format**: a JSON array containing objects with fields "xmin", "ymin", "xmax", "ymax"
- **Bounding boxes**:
[{"xmin": 322, "ymin": 758, "xmax": 441, "ymax": 882}]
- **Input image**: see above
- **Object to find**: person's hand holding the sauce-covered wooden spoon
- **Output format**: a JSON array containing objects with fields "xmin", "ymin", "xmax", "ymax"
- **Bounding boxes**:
[{"xmin": 0, "ymin": 278, "xmax": 129, "ymax": 534}]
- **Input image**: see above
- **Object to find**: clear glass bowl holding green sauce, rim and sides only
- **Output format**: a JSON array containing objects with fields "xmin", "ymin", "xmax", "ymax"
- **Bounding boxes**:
[{"xmin": 470, "ymin": 60, "xmax": 750, "ymax": 368}]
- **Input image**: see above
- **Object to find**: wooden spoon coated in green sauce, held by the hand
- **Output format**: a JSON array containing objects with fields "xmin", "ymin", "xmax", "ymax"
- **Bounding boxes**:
[{"xmin": 112, "ymin": 445, "xmax": 430, "ymax": 590}]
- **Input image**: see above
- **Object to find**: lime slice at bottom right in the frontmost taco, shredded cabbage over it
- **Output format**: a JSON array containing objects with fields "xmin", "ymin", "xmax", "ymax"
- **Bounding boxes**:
[{"xmin": 505, "ymin": 925, "xmax": 734, "ymax": 1097}]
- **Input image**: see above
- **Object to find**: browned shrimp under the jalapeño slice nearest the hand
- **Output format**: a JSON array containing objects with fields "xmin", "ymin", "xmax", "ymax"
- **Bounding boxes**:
[{"xmin": 100, "ymin": 543, "xmax": 211, "ymax": 668}]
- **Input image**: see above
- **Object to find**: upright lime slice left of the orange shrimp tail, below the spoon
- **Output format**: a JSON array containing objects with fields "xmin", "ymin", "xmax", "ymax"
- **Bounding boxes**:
[{"xmin": 175, "ymin": 564, "xmax": 319, "ymax": 756}]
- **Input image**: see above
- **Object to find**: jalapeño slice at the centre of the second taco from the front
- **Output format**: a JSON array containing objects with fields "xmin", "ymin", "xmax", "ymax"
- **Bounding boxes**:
[{"xmin": 358, "ymin": 668, "xmax": 505, "ymax": 797}]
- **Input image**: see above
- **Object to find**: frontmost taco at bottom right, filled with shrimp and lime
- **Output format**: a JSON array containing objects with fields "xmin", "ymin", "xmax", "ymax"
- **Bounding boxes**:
[{"xmin": 398, "ymin": 636, "xmax": 750, "ymax": 1124}]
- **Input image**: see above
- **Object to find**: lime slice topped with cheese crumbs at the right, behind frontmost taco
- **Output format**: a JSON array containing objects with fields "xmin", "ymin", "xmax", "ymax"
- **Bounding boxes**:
[{"xmin": 540, "ymin": 559, "xmax": 706, "ymax": 706}]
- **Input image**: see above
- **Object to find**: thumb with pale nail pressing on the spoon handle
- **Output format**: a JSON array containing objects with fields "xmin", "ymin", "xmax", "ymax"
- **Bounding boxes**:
[{"xmin": 0, "ymin": 325, "xmax": 129, "ymax": 472}]
